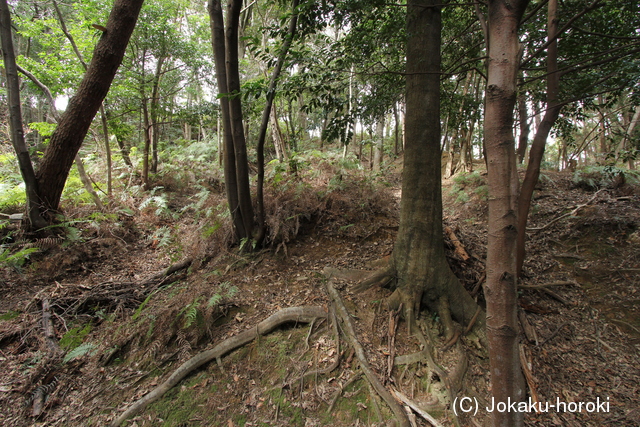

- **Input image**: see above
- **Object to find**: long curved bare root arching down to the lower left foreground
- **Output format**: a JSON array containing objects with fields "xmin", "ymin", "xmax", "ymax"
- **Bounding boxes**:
[{"xmin": 110, "ymin": 306, "xmax": 327, "ymax": 427}]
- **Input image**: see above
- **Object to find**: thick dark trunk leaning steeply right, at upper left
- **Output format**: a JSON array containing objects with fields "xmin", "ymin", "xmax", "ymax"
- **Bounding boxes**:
[{"xmin": 36, "ymin": 0, "xmax": 143, "ymax": 216}]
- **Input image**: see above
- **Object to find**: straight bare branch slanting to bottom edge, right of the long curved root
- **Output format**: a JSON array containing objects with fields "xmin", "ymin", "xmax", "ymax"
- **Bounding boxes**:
[{"xmin": 326, "ymin": 280, "xmax": 410, "ymax": 427}]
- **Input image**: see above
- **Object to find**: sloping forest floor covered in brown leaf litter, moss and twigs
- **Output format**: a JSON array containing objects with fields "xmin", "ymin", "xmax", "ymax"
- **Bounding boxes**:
[{"xmin": 0, "ymin": 159, "xmax": 640, "ymax": 427}]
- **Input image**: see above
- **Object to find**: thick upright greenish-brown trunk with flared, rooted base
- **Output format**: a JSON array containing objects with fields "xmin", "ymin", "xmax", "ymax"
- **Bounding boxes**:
[{"xmin": 393, "ymin": 0, "xmax": 484, "ymax": 329}]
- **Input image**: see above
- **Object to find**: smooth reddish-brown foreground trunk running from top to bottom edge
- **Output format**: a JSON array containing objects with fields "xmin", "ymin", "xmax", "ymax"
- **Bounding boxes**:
[{"xmin": 484, "ymin": 0, "xmax": 528, "ymax": 427}]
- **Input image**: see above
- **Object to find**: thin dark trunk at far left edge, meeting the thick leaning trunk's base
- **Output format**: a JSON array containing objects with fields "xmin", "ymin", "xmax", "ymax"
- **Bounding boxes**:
[{"xmin": 0, "ymin": 0, "xmax": 47, "ymax": 229}]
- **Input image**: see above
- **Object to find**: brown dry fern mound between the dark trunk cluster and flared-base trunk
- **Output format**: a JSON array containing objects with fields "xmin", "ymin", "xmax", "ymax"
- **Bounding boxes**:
[{"xmin": 264, "ymin": 150, "xmax": 396, "ymax": 250}]
